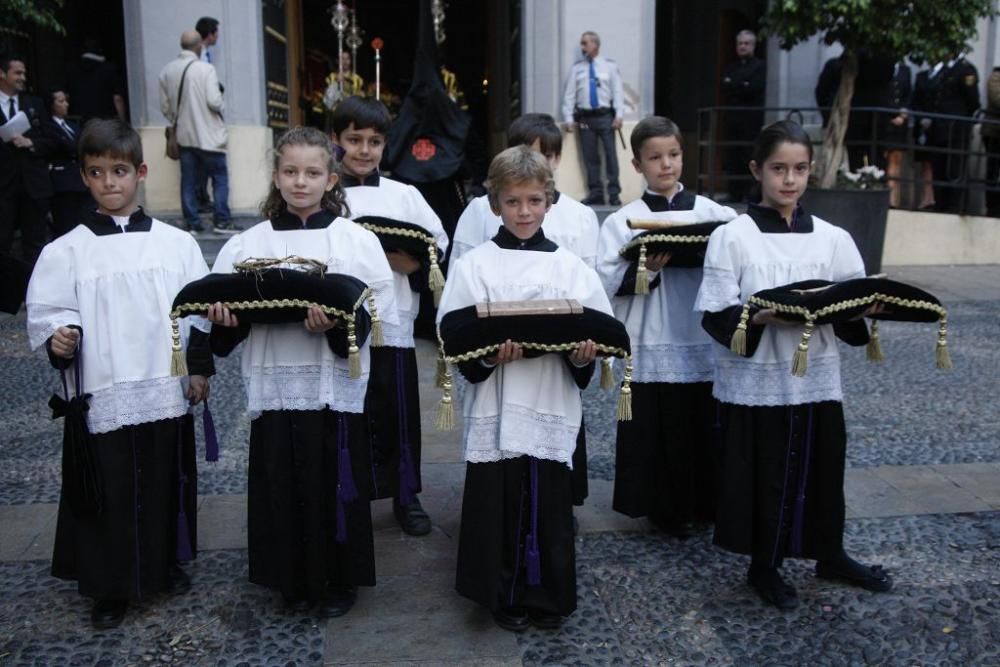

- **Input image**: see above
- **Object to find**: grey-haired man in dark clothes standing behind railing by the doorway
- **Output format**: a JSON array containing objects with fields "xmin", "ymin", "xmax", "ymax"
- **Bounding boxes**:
[{"xmin": 721, "ymin": 30, "xmax": 767, "ymax": 202}]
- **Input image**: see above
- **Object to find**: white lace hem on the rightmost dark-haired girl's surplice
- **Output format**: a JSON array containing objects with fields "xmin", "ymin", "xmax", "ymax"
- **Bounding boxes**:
[{"xmin": 713, "ymin": 351, "xmax": 844, "ymax": 405}]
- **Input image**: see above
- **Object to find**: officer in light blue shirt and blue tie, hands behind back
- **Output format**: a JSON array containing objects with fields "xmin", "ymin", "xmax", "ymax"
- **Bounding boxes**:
[{"xmin": 562, "ymin": 32, "xmax": 625, "ymax": 206}]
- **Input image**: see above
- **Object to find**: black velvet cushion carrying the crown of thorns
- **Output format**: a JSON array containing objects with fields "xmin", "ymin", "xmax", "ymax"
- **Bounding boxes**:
[{"xmin": 171, "ymin": 268, "xmax": 370, "ymax": 336}]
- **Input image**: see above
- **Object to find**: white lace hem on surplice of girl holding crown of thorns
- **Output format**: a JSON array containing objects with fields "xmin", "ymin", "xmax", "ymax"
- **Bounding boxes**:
[{"xmin": 243, "ymin": 362, "xmax": 368, "ymax": 415}]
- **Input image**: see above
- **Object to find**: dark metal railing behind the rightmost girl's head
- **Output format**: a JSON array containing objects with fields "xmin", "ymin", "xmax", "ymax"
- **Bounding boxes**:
[{"xmin": 697, "ymin": 107, "xmax": 1000, "ymax": 216}]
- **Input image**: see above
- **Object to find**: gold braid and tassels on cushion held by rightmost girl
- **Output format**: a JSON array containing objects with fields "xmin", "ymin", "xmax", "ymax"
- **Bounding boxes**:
[{"xmin": 748, "ymin": 292, "xmax": 952, "ymax": 377}]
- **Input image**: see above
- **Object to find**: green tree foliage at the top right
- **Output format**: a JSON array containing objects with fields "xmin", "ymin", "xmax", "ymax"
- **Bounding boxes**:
[{"xmin": 764, "ymin": 0, "xmax": 997, "ymax": 63}]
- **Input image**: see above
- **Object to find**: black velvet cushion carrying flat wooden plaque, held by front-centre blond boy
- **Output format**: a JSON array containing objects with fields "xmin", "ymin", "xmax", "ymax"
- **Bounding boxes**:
[{"xmin": 440, "ymin": 306, "xmax": 631, "ymax": 360}]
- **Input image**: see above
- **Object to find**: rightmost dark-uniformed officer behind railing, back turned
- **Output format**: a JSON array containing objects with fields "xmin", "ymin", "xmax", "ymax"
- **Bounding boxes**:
[{"xmin": 930, "ymin": 56, "xmax": 979, "ymax": 213}]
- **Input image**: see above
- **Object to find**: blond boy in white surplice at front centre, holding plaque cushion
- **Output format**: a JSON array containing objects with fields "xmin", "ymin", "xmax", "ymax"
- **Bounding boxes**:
[{"xmin": 438, "ymin": 146, "xmax": 611, "ymax": 631}]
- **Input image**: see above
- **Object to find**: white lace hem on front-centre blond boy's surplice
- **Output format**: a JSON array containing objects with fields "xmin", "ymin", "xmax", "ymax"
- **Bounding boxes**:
[{"xmin": 465, "ymin": 403, "xmax": 580, "ymax": 468}]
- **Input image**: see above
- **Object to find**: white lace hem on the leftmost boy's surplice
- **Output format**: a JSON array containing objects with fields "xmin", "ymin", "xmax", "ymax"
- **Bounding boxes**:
[{"xmin": 88, "ymin": 377, "xmax": 188, "ymax": 433}]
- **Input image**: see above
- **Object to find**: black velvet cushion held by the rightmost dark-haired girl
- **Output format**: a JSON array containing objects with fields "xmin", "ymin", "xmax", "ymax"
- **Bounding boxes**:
[{"xmin": 750, "ymin": 278, "xmax": 944, "ymax": 324}]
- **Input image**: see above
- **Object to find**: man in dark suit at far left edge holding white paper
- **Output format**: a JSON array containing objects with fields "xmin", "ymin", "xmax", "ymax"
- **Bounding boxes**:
[{"xmin": 0, "ymin": 55, "xmax": 52, "ymax": 265}]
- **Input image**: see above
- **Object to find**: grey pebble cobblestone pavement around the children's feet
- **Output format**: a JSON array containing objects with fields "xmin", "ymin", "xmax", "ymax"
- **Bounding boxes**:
[{"xmin": 0, "ymin": 268, "xmax": 1000, "ymax": 667}]
